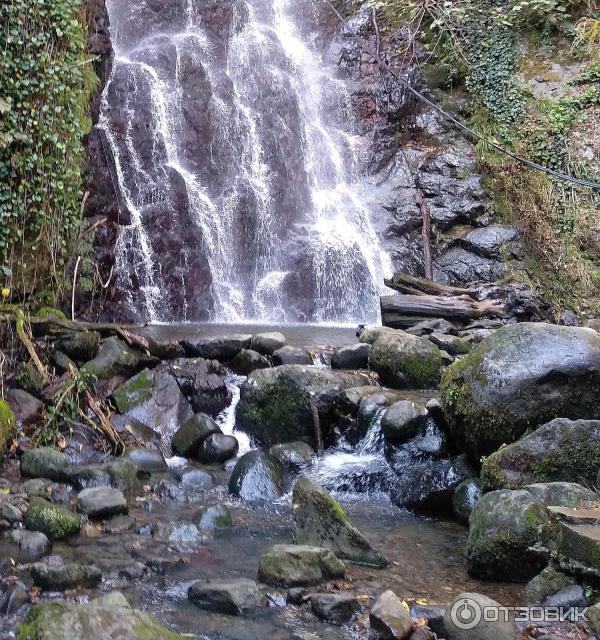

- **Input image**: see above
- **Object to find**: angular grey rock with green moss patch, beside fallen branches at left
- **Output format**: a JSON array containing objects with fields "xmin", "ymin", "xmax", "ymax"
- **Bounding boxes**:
[{"xmin": 112, "ymin": 369, "xmax": 194, "ymax": 441}]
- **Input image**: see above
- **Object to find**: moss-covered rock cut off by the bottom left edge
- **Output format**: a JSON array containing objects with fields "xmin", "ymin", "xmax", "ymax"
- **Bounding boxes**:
[{"xmin": 19, "ymin": 593, "xmax": 184, "ymax": 640}]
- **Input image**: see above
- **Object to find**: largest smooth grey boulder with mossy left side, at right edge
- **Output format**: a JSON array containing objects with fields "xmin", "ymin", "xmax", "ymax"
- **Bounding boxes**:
[{"xmin": 441, "ymin": 323, "xmax": 600, "ymax": 458}]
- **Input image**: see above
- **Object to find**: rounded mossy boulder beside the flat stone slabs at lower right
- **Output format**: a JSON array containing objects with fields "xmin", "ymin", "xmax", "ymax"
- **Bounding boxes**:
[{"xmin": 466, "ymin": 482, "xmax": 597, "ymax": 582}]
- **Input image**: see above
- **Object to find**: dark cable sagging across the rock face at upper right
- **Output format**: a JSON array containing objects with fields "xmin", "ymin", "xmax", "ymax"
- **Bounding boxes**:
[{"xmin": 323, "ymin": 0, "xmax": 600, "ymax": 189}]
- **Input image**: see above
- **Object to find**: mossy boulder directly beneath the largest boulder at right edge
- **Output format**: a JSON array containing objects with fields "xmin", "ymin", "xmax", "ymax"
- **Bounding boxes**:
[{"xmin": 481, "ymin": 418, "xmax": 600, "ymax": 490}]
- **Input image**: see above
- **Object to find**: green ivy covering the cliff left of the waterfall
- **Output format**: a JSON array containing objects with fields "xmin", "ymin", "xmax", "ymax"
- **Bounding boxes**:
[{"xmin": 0, "ymin": 0, "xmax": 96, "ymax": 293}]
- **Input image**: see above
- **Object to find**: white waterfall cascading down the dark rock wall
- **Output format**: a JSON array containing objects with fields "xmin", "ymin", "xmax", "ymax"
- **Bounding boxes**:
[{"xmin": 100, "ymin": 0, "xmax": 389, "ymax": 323}]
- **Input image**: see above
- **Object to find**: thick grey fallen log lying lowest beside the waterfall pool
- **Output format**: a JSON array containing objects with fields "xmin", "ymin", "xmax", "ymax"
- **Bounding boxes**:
[{"xmin": 381, "ymin": 294, "xmax": 505, "ymax": 329}]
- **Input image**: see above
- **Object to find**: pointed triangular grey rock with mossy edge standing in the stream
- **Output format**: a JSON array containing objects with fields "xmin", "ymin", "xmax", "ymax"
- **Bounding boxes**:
[{"xmin": 292, "ymin": 476, "xmax": 388, "ymax": 568}]
